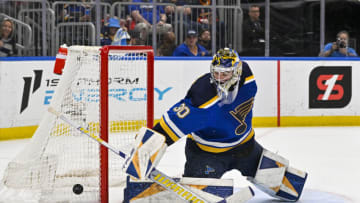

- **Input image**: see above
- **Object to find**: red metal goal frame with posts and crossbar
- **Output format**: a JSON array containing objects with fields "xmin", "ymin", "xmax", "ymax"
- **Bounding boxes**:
[{"xmin": 100, "ymin": 45, "xmax": 154, "ymax": 203}]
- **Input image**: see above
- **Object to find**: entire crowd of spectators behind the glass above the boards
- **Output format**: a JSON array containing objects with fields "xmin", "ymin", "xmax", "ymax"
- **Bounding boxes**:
[{"xmin": 0, "ymin": 0, "xmax": 357, "ymax": 57}]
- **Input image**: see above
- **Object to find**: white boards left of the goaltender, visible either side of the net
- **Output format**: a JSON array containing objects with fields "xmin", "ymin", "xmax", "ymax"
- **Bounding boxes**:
[{"xmin": 0, "ymin": 60, "xmax": 214, "ymax": 128}]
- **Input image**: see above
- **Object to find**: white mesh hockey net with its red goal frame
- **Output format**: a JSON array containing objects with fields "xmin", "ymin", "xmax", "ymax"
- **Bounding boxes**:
[{"xmin": 0, "ymin": 46, "xmax": 154, "ymax": 202}]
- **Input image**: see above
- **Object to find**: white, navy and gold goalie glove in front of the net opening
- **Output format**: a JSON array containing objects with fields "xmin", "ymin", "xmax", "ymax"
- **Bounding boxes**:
[{"xmin": 123, "ymin": 127, "xmax": 167, "ymax": 180}]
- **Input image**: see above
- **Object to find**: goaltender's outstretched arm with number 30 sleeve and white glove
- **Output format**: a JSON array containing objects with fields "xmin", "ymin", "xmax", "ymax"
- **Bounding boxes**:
[{"xmin": 123, "ymin": 99, "xmax": 207, "ymax": 179}]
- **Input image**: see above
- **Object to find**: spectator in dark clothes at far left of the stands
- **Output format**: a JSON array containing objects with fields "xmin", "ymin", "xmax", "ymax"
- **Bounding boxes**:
[{"xmin": 0, "ymin": 18, "xmax": 17, "ymax": 57}]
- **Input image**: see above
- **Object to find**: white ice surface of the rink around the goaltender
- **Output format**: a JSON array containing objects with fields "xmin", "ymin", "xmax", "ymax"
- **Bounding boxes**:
[{"xmin": 0, "ymin": 127, "xmax": 360, "ymax": 203}]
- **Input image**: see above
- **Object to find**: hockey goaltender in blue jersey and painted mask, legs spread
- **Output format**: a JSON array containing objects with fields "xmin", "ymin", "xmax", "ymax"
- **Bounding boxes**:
[{"xmin": 125, "ymin": 48, "xmax": 307, "ymax": 202}]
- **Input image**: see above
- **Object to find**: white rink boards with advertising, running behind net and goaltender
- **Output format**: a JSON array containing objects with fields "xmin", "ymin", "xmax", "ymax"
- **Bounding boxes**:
[{"xmin": 0, "ymin": 57, "xmax": 360, "ymax": 128}]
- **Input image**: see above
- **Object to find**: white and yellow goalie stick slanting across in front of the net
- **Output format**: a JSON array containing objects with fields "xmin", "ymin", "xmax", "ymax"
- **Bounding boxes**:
[{"xmin": 48, "ymin": 107, "xmax": 254, "ymax": 203}]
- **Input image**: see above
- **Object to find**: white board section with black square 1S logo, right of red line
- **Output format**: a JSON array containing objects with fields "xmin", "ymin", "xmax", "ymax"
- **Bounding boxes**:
[{"xmin": 280, "ymin": 60, "xmax": 360, "ymax": 116}]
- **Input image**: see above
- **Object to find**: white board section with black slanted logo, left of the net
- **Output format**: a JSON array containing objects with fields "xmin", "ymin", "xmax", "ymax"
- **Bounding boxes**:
[{"xmin": 0, "ymin": 60, "xmax": 59, "ymax": 128}]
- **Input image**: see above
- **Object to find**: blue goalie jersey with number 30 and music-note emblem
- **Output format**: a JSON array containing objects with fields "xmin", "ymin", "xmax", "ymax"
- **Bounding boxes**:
[{"xmin": 154, "ymin": 62, "xmax": 257, "ymax": 153}]
